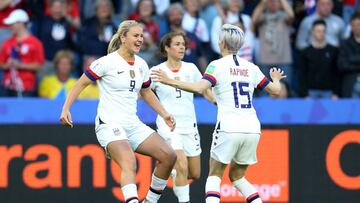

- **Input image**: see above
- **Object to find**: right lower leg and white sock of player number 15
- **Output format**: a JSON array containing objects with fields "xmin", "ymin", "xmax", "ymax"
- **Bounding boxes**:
[{"xmin": 229, "ymin": 161, "xmax": 262, "ymax": 203}]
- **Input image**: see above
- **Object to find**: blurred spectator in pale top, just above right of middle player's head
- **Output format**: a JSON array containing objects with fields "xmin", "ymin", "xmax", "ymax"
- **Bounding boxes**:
[{"xmin": 181, "ymin": 0, "xmax": 210, "ymax": 43}]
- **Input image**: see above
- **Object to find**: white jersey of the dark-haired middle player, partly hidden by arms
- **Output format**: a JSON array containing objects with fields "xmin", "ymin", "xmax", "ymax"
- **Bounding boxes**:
[{"xmin": 150, "ymin": 62, "xmax": 202, "ymax": 134}]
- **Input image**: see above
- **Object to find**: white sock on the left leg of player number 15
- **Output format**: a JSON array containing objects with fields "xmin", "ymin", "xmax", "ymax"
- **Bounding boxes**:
[{"xmin": 205, "ymin": 176, "xmax": 221, "ymax": 203}]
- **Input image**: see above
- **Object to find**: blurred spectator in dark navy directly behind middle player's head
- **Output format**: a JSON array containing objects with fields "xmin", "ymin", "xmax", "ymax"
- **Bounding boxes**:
[{"xmin": 168, "ymin": 3, "xmax": 207, "ymax": 73}]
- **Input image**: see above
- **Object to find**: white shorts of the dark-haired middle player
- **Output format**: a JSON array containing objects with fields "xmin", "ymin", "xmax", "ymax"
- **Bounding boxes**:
[{"xmin": 158, "ymin": 129, "xmax": 201, "ymax": 157}]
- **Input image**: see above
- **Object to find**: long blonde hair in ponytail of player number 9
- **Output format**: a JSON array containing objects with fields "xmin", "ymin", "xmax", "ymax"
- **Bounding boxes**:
[{"xmin": 107, "ymin": 20, "xmax": 140, "ymax": 54}]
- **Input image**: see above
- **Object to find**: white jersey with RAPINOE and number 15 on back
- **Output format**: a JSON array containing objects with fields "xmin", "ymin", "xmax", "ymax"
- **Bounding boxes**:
[{"xmin": 203, "ymin": 55, "xmax": 269, "ymax": 133}]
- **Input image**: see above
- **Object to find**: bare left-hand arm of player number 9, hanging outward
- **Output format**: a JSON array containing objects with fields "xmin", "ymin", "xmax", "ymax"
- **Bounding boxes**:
[{"xmin": 60, "ymin": 74, "xmax": 92, "ymax": 128}]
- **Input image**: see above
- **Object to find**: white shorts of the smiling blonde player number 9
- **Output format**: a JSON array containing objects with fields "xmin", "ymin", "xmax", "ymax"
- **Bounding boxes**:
[{"xmin": 95, "ymin": 118, "xmax": 155, "ymax": 153}]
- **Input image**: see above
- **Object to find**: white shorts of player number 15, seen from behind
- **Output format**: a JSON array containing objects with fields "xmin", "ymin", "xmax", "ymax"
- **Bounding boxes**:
[{"xmin": 211, "ymin": 131, "xmax": 260, "ymax": 165}]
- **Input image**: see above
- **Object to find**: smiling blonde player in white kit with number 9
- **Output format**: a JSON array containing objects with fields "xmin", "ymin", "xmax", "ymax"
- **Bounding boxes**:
[{"xmin": 60, "ymin": 21, "xmax": 176, "ymax": 203}]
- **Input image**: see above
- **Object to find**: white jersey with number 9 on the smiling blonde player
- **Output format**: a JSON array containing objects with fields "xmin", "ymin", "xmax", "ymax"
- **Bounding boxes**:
[{"xmin": 85, "ymin": 52, "xmax": 151, "ymax": 128}]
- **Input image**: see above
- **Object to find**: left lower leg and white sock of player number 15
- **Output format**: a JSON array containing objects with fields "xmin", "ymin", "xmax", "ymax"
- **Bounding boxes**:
[{"xmin": 205, "ymin": 158, "xmax": 226, "ymax": 203}]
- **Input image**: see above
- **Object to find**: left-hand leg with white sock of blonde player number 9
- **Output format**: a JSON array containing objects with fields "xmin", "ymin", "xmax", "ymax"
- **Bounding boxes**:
[{"xmin": 107, "ymin": 140, "xmax": 139, "ymax": 203}]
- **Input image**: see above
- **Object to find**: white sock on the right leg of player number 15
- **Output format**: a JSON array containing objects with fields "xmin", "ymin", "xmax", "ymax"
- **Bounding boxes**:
[{"xmin": 232, "ymin": 177, "xmax": 262, "ymax": 203}]
